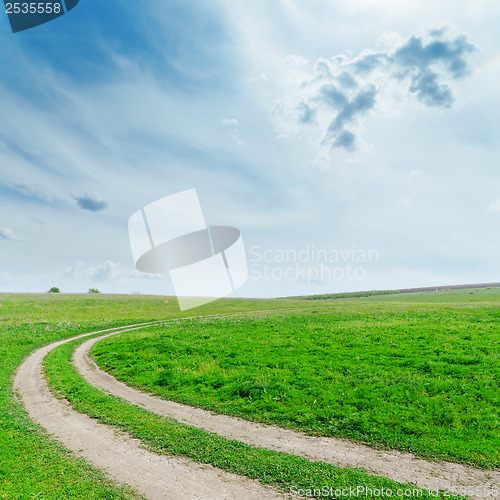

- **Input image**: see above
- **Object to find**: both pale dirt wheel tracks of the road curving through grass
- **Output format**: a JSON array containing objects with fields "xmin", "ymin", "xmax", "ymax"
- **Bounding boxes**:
[{"xmin": 14, "ymin": 322, "xmax": 500, "ymax": 500}]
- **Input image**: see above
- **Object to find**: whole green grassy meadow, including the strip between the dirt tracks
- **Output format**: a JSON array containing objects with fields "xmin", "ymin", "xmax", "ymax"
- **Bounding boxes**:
[{"xmin": 0, "ymin": 289, "xmax": 500, "ymax": 499}]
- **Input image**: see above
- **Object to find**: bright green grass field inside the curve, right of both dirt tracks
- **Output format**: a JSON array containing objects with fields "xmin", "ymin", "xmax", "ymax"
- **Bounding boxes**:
[{"xmin": 92, "ymin": 289, "xmax": 500, "ymax": 469}]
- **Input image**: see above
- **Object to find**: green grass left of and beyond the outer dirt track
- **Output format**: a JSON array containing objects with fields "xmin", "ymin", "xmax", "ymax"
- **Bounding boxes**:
[{"xmin": 0, "ymin": 294, "xmax": 310, "ymax": 500}]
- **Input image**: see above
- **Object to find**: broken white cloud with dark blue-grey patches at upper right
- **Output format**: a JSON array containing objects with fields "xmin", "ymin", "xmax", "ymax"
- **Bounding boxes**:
[{"xmin": 274, "ymin": 29, "xmax": 475, "ymax": 161}]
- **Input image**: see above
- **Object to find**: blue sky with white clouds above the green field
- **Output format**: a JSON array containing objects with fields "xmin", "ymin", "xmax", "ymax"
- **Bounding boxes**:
[{"xmin": 0, "ymin": 0, "xmax": 500, "ymax": 297}]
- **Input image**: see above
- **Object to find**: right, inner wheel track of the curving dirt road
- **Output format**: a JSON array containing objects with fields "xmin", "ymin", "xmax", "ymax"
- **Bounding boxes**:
[{"xmin": 73, "ymin": 333, "xmax": 500, "ymax": 499}]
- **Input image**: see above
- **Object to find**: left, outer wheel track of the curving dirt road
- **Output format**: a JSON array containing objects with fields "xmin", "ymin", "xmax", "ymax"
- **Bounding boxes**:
[{"xmin": 14, "ymin": 325, "xmax": 286, "ymax": 500}]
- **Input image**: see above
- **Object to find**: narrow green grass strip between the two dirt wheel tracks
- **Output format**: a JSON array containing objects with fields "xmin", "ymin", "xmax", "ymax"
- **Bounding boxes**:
[{"xmin": 45, "ymin": 332, "xmax": 456, "ymax": 498}]
